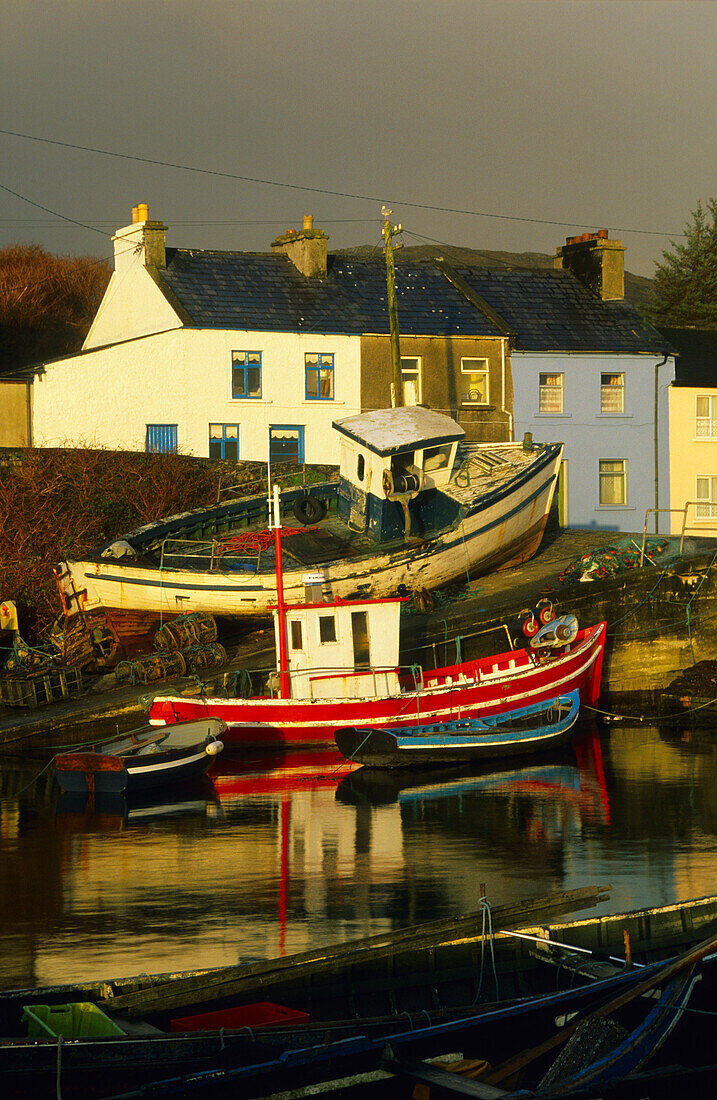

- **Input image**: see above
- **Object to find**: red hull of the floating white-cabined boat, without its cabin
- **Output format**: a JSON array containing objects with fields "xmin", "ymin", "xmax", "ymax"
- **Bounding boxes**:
[{"xmin": 150, "ymin": 623, "xmax": 606, "ymax": 748}]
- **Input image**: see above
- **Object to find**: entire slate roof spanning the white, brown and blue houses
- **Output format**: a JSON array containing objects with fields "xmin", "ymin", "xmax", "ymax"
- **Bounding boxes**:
[{"xmin": 161, "ymin": 249, "xmax": 672, "ymax": 353}]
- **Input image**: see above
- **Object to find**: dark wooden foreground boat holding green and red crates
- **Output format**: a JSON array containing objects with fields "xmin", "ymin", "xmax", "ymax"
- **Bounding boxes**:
[{"xmin": 0, "ymin": 888, "xmax": 717, "ymax": 1098}]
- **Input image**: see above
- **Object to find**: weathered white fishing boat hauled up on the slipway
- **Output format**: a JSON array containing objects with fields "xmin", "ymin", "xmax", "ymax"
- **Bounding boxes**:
[{"xmin": 55, "ymin": 407, "xmax": 562, "ymax": 646}]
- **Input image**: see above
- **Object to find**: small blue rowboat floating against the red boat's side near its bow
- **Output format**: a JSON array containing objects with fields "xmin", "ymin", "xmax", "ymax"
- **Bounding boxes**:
[{"xmin": 334, "ymin": 691, "xmax": 580, "ymax": 768}]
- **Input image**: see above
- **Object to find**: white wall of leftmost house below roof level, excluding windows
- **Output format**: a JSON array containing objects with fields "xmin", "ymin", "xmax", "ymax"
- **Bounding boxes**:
[{"xmin": 33, "ymin": 325, "xmax": 361, "ymax": 463}]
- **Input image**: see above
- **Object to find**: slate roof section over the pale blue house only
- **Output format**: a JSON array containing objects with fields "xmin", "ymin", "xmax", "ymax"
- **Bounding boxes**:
[{"xmin": 450, "ymin": 267, "xmax": 671, "ymax": 353}]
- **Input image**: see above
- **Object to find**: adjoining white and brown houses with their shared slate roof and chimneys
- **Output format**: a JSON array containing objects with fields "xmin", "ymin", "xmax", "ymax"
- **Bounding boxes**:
[{"xmin": 33, "ymin": 207, "xmax": 511, "ymax": 462}]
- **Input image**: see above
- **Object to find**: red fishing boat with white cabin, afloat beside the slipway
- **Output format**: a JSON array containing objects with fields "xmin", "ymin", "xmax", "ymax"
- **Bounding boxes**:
[{"xmin": 150, "ymin": 585, "xmax": 605, "ymax": 748}]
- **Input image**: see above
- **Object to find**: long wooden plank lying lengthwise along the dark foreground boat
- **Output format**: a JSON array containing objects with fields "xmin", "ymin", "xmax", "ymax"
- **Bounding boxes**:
[{"xmin": 98, "ymin": 887, "xmax": 610, "ymax": 1014}]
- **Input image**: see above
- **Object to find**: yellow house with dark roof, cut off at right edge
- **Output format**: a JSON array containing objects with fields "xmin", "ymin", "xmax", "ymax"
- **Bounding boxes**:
[{"xmin": 662, "ymin": 328, "xmax": 717, "ymax": 536}]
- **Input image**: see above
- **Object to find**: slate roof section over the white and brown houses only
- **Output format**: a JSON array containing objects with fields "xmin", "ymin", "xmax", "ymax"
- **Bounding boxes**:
[{"xmin": 161, "ymin": 249, "xmax": 500, "ymax": 336}]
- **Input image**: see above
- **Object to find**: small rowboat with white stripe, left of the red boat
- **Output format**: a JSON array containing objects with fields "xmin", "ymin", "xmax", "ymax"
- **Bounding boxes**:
[{"xmin": 53, "ymin": 718, "xmax": 227, "ymax": 794}]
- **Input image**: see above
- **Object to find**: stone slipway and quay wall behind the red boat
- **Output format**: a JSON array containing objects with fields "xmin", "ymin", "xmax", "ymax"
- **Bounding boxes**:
[{"xmin": 0, "ymin": 529, "xmax": 717, "ymax": 755}]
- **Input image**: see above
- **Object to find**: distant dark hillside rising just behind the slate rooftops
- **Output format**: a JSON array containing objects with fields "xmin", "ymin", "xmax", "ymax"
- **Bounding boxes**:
[{"xmin": 333, "ymin": 244, "xmax": 652, "ymax": 312}]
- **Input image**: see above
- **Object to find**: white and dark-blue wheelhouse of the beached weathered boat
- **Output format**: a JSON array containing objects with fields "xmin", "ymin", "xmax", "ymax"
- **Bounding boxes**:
[{"xmin": 333, "ymin": 405, "xmax": 465, "ymax": 542}]
